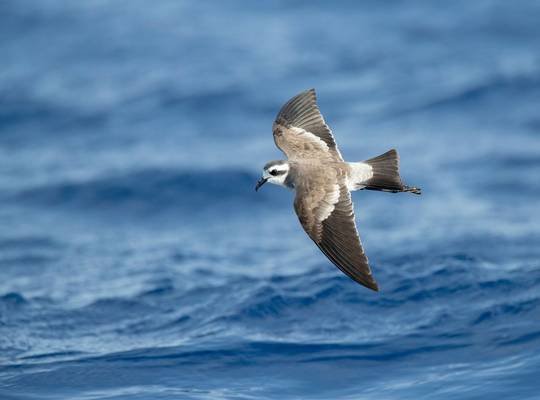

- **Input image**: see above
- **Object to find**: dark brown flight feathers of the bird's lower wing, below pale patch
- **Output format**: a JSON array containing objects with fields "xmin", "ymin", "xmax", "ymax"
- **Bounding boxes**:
[{"xmin": 294, "ymin": 185, "xmax": 379, "ymax": 291}]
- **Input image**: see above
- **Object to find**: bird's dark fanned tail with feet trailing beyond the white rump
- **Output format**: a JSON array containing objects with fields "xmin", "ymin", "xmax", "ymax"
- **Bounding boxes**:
[{"xmin": 363, "ymin": 149, "xmax": 422, "ymax": 194}]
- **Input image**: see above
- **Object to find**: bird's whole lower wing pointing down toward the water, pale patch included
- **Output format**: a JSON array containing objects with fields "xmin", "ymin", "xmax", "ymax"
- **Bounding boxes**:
[{"xmin": 294, "ymin": 181, "xmax": 379, "ymax": 291}]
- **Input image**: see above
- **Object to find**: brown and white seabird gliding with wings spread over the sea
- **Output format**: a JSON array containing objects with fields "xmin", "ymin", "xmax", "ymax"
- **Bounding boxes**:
[{"xmin": 255, "ymin": 89, "xmax": 421, "ymax": 291}]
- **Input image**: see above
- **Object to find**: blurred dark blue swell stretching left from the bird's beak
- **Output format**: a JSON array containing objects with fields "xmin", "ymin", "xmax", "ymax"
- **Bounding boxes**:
[{"xmin": 12, "ymin": 169, "xmax": 280, "ymax": 214}]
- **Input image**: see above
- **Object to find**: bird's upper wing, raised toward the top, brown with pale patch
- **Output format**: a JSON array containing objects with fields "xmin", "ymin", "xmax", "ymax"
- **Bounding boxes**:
[{"xmin": 272, "ymin": 89, "xmax": 343, "ymax": 161}]
